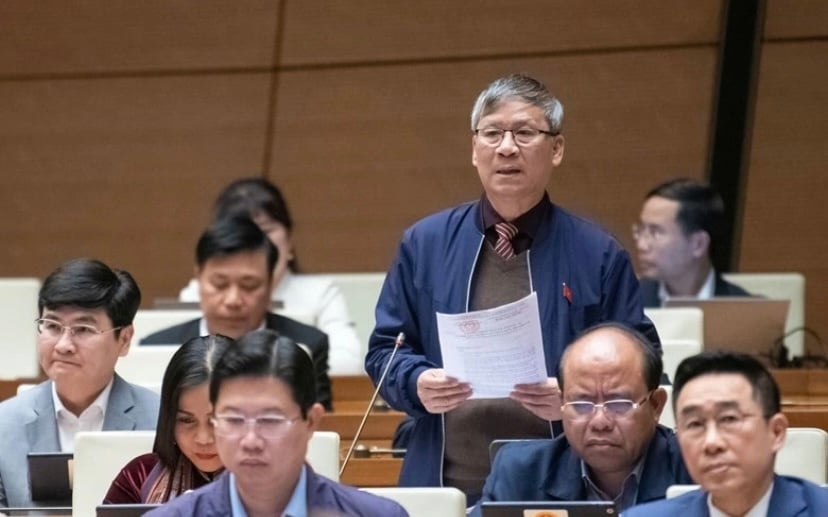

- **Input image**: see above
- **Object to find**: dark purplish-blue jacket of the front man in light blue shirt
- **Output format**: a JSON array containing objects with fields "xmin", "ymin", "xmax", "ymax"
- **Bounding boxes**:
[{"xmin": 146, "ymin": 466, "xmax": 408, "ymax": 517}]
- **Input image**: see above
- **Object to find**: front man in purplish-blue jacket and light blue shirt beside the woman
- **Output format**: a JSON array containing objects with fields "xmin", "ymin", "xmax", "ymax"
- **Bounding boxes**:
[{"xmin": 148, "ymin": 330, "xmax": 408, "ymax": 517}]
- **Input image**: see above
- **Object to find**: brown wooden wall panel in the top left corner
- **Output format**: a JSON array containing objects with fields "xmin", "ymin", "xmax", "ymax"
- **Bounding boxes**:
[{"xmin": 0, "ymin": 0, "xmax": 279, "ymax": 76}]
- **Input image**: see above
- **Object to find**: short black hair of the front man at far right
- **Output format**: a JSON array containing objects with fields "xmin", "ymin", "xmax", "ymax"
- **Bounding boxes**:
[{"xmin": 673, "ymin": 350, "xmax": 782, "ymax": 419}]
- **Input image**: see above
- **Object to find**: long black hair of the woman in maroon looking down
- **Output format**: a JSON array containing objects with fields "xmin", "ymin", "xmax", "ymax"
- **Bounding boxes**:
[{"xmin": 152, "ymin": 335, "xmax": 233, "ymax": 476}]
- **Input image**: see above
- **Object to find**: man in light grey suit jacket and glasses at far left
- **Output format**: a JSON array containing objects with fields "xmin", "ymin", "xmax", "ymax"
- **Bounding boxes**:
[{"xmin": 0, "ymin": 259, "xmax": 159, "ymax": 511}]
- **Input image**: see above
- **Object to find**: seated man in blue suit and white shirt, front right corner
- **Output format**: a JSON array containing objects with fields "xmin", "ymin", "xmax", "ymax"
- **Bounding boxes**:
[{"xmin": 624, "ymin": 352, "xmax": 828, "ymax": 517}]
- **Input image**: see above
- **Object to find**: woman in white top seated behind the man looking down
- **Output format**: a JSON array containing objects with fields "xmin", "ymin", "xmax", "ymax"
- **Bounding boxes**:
[{"xmin": 179, "ymin": 178, "xmax": 365, "ymax": 375}]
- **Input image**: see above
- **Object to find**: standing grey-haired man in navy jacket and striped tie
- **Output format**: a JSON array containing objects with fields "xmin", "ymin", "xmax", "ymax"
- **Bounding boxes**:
[{"xmin": 365, "ymin": 75, "xmax": 657, "ymax": 503}]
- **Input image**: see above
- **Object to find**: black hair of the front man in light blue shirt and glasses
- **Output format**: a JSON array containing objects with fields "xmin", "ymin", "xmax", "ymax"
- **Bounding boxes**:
[{"xmin": 210, "ymin": 329, "xmax": 316, "ymax": 418}]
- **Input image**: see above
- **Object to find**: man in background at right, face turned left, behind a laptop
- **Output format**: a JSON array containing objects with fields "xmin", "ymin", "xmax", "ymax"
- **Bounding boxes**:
[{"xmin": 633, "ymin": 178, "xmax": 750, "ymax": 307}]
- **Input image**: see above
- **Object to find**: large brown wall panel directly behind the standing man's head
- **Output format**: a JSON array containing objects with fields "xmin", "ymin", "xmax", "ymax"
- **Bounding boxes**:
[{"xmin": 269, "ymin": 46, "xmax": 716, "ymax": 271}]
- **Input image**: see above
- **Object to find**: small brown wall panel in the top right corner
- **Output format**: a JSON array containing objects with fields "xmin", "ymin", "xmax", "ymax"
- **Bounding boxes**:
[{"xmin": 765, "ymin": 0, "xmax": 828, "ymax": 39}]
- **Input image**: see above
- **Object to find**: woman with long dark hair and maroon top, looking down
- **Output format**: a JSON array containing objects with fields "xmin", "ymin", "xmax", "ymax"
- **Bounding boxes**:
[{"xmin": 104, "ymin": 336, "xmax": 233, "ymax": 504}]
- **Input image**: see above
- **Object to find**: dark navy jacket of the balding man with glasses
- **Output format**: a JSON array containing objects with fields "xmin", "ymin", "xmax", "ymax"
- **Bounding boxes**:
[{"xmin": 472, "ymin": 426, "xmax": 693, "ymax": 516}]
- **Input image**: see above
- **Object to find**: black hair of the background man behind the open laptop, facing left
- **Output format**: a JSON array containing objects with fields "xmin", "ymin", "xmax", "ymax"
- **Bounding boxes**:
[{"xmin": 644, "ymin": 178, "xmax": 725, "ymax": 257}]
